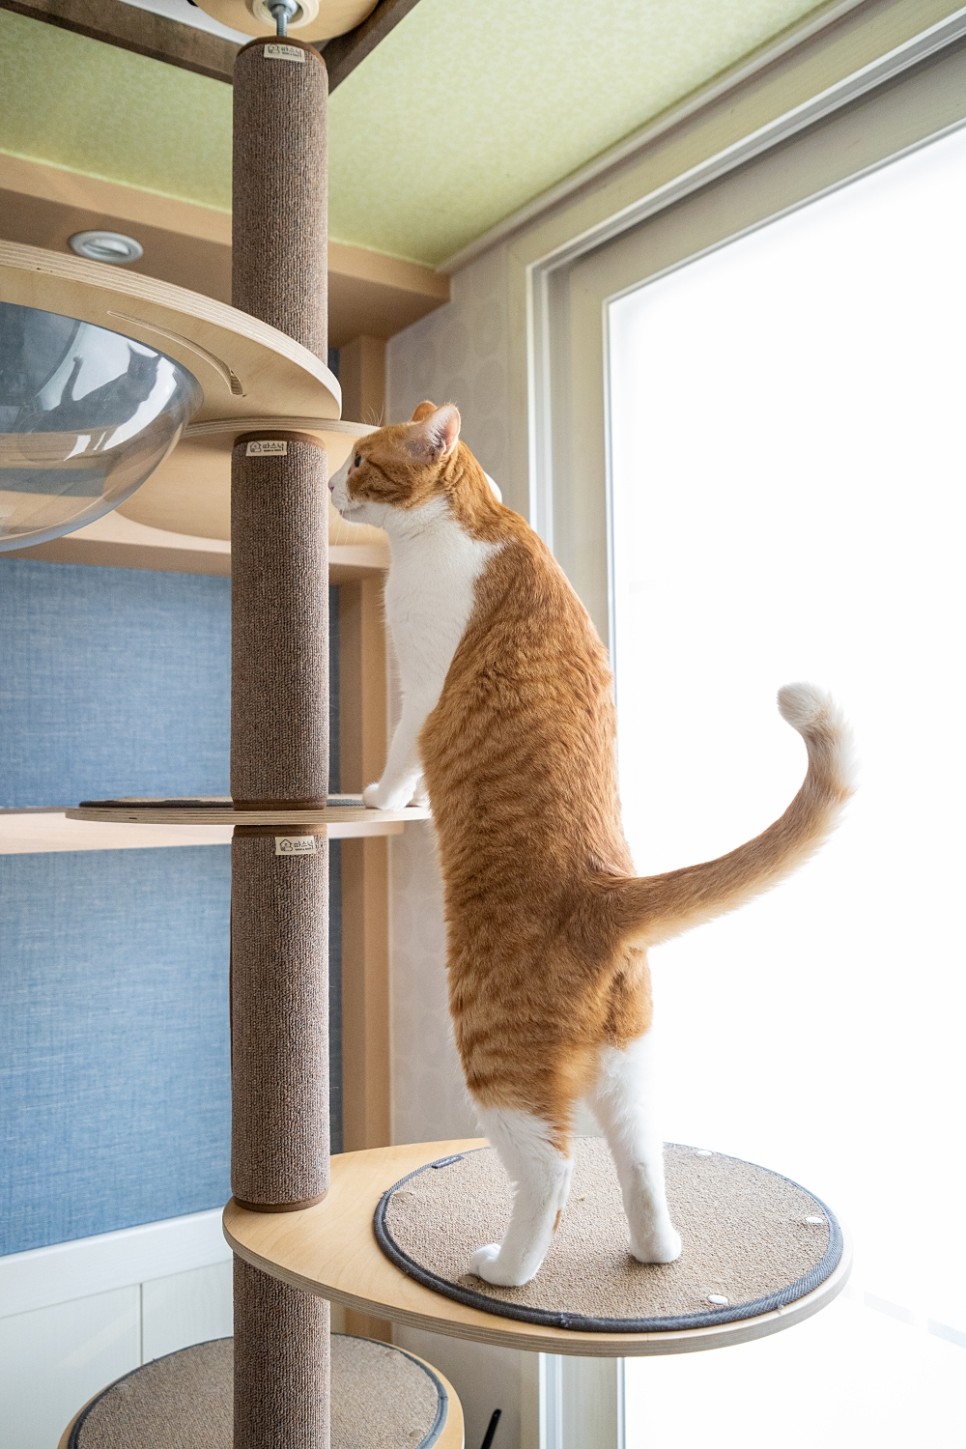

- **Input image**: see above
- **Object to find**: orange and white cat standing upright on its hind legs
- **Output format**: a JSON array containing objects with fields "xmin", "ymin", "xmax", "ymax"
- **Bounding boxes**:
[{"xmin": 330, "ymin": 403, "xmax": 852, "ymax": 1284}]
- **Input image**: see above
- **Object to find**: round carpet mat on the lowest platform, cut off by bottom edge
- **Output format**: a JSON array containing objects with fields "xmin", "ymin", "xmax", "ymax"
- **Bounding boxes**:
[{"xmin": 65, "ymin": 1333, "xmax": 448, "ymax": 1449}]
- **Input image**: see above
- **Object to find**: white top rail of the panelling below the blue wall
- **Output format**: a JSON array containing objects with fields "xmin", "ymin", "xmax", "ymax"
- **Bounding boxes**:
[{"xmin": 0, "ymin": 1208, "xmax": 232, "ymax": 1319}]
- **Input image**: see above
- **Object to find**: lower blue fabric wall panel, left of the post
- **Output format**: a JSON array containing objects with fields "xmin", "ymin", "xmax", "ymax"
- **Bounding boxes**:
[{"xmin": 0, "ymin": 848, "xmax": 230, "ymax": 1252}]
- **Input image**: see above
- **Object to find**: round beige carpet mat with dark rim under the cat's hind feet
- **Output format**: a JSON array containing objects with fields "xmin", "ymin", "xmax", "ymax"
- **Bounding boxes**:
[{"xmin": 375, "ymin": 1137, "xmax": 843, "ymax": 1333}]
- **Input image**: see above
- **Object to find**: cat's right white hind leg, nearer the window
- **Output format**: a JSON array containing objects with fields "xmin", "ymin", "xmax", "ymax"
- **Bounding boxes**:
[{"xmin": 588, "ymin": 1032, "xmax": 681, "ymax": 1264}]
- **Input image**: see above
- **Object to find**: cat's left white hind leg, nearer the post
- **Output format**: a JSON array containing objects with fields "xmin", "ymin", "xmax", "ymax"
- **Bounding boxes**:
[{"xmin": 469, "ymin": 1107, "xmax": 574, "ymax": 1288}]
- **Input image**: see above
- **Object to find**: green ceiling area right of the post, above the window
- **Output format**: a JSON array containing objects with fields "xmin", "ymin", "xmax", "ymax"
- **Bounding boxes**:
[{"xmin": 322, "ymin": 0, "xmax": 817, "ymax": 262}]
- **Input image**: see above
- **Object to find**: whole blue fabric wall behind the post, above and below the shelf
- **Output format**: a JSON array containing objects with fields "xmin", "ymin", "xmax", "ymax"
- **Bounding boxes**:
[{"xmin": 0, "ymin": 558, "xmax": 342, "ymax": 1253}]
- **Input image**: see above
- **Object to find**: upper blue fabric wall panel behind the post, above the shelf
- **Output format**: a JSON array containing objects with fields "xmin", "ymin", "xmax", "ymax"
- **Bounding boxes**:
[{"xmin": 0, "ymin": 558, "xmax": 339, "ymax": 807}]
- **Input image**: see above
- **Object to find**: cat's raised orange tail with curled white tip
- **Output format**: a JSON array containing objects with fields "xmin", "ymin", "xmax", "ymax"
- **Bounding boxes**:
[{"xmin": 601, "ymin": 684, "xmax": 854, "ymax": 945}]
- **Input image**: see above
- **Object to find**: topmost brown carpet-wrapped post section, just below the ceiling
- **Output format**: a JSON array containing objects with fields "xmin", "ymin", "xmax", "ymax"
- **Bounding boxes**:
[{"xmin": 232, "ymin": 38, "xmax": 329, "ymax": 362}]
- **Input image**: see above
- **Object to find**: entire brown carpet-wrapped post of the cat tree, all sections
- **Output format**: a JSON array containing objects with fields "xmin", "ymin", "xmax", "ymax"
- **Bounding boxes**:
[{"xmin": 232, "ymin": 31, "xmax": 330, "ymax": 1449}]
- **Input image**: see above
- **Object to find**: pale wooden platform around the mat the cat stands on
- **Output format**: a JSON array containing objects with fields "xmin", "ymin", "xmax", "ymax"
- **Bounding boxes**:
[{"xmin": 224, "ymin": 1140, "xmax": 850, "ymax": 1358}]
